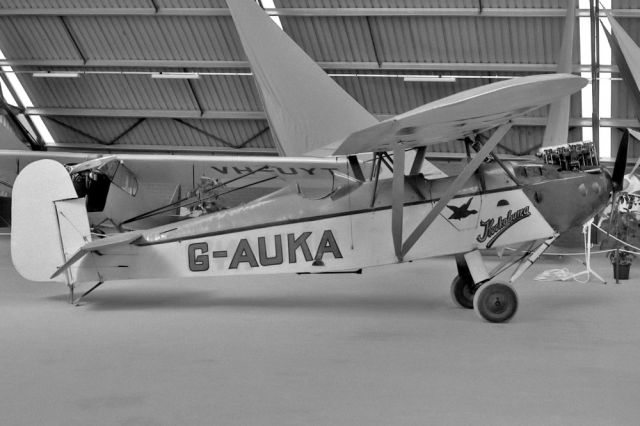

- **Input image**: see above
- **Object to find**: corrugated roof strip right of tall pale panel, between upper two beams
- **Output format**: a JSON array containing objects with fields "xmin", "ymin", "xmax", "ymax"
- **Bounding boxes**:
[{"xmin": 283, "ymin": 16, "xmax": 563, "ymax": 64}]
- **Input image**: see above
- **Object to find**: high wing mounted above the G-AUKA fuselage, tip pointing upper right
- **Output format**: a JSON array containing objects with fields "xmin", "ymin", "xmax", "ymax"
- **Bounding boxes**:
[{"xmin": 333, "ymin": 74, "xmax": 587, "ymax": 155}]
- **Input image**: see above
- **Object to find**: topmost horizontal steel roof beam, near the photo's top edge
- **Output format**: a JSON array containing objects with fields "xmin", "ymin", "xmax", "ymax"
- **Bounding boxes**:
[{"xmin": 0, "ymin": 7, "xmax": 640, "ymax": 18}]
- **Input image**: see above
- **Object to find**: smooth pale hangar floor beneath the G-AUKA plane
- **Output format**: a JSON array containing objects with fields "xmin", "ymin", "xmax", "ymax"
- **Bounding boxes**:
[{"xmin": 0, "ymin": 237, "xmax": 640, "ymax": 425}]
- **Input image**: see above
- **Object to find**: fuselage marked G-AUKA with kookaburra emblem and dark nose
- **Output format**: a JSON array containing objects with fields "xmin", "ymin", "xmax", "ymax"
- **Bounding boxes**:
[{"xmin": 72, "ymin": 161, "xmax": 611, "ymax": 281}]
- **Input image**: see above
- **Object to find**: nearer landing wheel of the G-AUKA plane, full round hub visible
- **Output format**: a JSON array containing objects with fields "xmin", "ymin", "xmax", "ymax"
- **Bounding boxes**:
[{"xmin": 473, "ymin": 282, "xmax": 518, "ymax": 322}]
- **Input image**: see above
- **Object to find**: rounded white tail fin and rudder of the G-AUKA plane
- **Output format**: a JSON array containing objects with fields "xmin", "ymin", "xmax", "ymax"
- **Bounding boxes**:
[{"xmin": 11, "ymin": 160, "xmax": 91, "ymax": 283}]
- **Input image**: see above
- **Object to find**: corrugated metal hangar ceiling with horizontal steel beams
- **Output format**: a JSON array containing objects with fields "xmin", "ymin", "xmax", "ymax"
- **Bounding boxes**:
[{"xmin": 0, "ymin": 0, "xmax": 640, "ymax": 155}]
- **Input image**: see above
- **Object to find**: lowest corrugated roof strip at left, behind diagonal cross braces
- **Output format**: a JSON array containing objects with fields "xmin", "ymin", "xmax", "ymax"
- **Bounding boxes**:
[{"xmin": 45, "ymin": 117, "xmax": 274, "ymax": 148}]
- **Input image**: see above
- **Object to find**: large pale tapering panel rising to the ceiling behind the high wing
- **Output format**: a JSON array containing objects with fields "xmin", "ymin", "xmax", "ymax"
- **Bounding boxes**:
[{"xmin": 227, "ymin": 0, "xmax": 378, "ymax": 156}]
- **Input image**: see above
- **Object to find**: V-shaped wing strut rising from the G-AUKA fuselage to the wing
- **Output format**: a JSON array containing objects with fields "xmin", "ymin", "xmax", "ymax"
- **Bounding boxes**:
[{"xmin": 391, "ymin": 121, "xmax": 512, "ymax": 262}]
